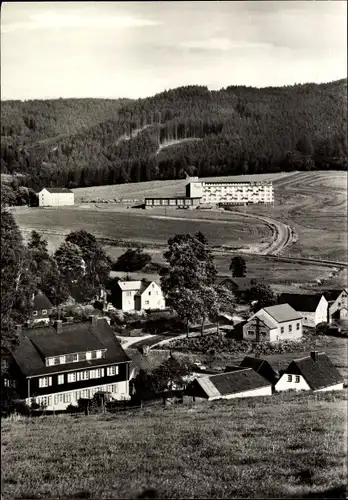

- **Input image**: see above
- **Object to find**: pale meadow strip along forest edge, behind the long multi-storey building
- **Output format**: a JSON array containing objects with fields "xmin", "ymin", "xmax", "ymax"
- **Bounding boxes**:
[{"xmin": 73, "ymin": 172, "xmax": 294, "ymax": 203}]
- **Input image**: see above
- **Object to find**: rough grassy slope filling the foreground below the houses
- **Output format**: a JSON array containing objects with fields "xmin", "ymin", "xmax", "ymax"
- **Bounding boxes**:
[{"xmin": 2, "ymin": 391, "xmax": 347, "ymax": 500}]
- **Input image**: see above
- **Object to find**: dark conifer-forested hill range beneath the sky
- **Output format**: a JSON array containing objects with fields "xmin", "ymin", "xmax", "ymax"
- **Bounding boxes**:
[{"xmin": 1, "ymin": 79, "xmax": 347, "ymax": 190}]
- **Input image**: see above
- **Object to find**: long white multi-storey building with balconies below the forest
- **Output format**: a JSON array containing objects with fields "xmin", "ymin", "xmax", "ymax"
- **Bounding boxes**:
[{"xmin": 186, "ymin": 179, "xmax": 274, "ymax": 205}]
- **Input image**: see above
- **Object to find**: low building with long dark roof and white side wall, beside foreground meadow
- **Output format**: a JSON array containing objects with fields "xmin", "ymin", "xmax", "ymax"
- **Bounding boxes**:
[{"xmin": 185, "ymin": 367, "xmax": 272, "ymax": 401}]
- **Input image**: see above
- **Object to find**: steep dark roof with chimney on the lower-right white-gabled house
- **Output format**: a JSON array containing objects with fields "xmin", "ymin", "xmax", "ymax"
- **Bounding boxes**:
[{"xmin": 285, "ymin": 352, "xmax": 343, "ymax": 390}]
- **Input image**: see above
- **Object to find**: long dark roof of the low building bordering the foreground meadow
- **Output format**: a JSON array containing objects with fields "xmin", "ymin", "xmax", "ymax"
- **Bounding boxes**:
[{"xmin": 196, "ymin": 368, "xmax": 271, "ymax": 397}]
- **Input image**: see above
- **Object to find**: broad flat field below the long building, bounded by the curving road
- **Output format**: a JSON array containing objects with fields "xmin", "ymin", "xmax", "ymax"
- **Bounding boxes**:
[{"xmin": 13, "ymin": 207, "xmax": 273, "ymax": 252}]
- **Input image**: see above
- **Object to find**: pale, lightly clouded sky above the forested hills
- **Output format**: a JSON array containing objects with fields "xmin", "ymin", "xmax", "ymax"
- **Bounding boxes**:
[{"xmin": 1, "ymin": 0, "xmax": 347, "ymax": 100}]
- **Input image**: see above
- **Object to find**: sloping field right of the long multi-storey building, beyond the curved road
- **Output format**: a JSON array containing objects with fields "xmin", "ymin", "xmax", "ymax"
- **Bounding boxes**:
[{"xmin": 237, "ymin": 171, "xmax": 348, "ymax": 262}]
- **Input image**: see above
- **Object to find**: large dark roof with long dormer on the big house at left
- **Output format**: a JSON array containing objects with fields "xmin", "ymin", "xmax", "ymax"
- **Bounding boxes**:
[{"xmin": 13, "ymin": 319, "xmax": 129, "ymax": 376}]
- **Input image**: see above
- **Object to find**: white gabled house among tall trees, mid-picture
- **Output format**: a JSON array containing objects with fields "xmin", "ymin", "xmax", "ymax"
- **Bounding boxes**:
[{"xmin": 113, "ymin": 280, "xmax": 165, "ymax": 312}]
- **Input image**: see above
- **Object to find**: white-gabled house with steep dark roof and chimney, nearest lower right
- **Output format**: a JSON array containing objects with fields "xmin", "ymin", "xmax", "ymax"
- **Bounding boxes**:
[{"xmin": 275, "ymin": 351, "xmax": 343, "ymax": 392}]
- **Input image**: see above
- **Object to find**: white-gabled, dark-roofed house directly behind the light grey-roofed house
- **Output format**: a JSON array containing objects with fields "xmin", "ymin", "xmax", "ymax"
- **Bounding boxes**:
[{"xmin": 279, "ymin": 293, "xmax": 328, "ymax": 328}]
